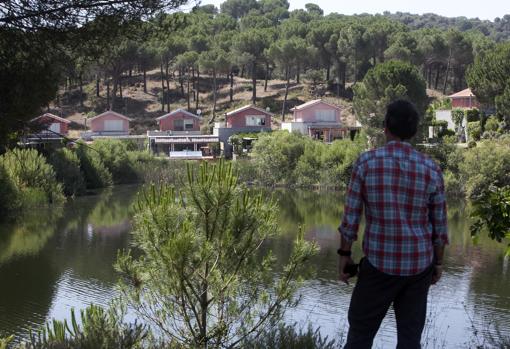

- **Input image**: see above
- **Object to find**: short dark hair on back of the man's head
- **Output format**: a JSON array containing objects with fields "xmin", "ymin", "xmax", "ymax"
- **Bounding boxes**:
[{"xmin": 384, "ymin": 100, "xmax": 420, "ymax": 140}]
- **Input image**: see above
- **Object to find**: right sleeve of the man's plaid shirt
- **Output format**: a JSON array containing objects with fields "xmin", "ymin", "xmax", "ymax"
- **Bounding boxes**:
[{"xmin": 429, "ymin": 169, "xmax": 448, "ymax": 246}]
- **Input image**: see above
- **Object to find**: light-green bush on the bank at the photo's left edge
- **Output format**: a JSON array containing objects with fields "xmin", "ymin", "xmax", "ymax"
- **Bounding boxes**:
[{"xmin": 0, "ymin": 149, "xmax": 65, "ymax": 207}]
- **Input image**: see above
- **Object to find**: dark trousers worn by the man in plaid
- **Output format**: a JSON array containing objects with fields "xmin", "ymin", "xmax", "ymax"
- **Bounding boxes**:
[{"xmin": 344, "ymin": 258, "xmax": 433, "ymax": 349}]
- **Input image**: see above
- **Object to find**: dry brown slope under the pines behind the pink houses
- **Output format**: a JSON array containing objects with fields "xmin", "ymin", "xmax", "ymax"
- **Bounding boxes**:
[{"xmin": 50, "ymin": 70, "xmax": 354, "ymax": 134}]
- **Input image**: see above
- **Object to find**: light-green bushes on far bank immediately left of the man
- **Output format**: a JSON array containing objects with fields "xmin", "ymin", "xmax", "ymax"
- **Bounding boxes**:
[{"xmin": 251, "ymin": 131, "xmax": 366, "ymax": 188}]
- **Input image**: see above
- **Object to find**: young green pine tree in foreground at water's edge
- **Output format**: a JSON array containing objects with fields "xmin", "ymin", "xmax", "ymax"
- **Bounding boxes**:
[{"xmin": 116, "ymin": 162, "xmax": 316, "ymax": 348}]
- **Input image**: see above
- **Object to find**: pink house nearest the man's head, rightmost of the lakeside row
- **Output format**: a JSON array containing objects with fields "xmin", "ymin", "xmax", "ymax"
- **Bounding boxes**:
[{"xmin": 282, "ymin": 99, "xmax": 360, "ymax": 143}]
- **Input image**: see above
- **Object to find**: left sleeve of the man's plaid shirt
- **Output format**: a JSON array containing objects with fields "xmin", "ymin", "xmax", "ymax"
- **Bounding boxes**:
[{"xmin": 338, "ymin": 158, "xmax": 364, "ymax": 241}]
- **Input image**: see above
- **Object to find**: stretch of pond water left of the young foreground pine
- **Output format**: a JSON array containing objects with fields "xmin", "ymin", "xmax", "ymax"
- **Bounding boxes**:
[{"xmin": 0, "ymin": 187, "xmax": 137, "ymax": 336}]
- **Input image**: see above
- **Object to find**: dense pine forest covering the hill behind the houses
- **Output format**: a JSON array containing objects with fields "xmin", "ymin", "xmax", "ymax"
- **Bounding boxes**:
[{"xmin": 0, "ymin": 0, "xmax": 510, "ymax": 148}]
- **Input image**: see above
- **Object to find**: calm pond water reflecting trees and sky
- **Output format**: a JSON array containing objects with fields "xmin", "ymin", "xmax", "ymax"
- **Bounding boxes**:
[{"xmin": 0, "ymin": 187, "xmax": 510, "ymax": 348}]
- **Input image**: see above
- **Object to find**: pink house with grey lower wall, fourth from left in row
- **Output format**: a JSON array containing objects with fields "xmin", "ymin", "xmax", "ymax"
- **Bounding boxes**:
[{"xmin": 213, "ymin": 104, "xmax": 274, "ymax": 158}]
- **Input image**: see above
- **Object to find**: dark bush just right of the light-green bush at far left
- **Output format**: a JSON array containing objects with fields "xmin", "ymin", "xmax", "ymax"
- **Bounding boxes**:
[{"xmin": 48, "ymin": 148, "xmax": 86, "ymax": 196}]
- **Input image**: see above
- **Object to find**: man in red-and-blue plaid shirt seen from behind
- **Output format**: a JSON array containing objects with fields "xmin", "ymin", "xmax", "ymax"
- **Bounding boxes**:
[{"xmin": 338, "ymin": 100, "xmax": 448, "ymax": 349}]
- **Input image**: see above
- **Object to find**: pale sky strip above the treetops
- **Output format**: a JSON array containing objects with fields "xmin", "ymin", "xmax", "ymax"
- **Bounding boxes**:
[{"xmin": 197, "ymin": 0, "xmax": 510, "ymax": 21}]
